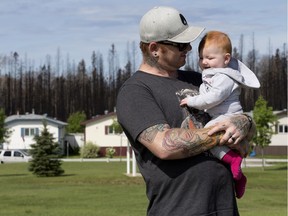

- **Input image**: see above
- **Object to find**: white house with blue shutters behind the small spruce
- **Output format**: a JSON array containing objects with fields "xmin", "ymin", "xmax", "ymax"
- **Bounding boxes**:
[{"xmin": 3, "ymin": 111, "xmax": 67, "ymax": 154}]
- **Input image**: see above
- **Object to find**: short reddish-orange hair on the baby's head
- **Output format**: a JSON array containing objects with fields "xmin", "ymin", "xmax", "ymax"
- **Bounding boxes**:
[{"xmin": 198, "ymin": 31, "xmax": 232, "ymax": 54}]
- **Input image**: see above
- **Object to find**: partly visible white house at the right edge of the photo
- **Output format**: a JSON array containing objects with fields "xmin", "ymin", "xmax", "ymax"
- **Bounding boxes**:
[{"xmin": 256, "ymin": 109, "xmax": 288, "ymax": 155}]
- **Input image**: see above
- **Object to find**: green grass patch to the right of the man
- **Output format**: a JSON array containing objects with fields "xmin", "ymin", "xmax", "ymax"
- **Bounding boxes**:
[{"xmin": 238, "ymin": 163, "xmax": 287, "ymax": 216}]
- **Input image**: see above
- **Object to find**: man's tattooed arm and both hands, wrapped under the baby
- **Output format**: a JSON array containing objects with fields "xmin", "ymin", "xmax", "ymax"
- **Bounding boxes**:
[{"xmin": 138, "ymin": 114, "xmax": 254, "ymax": 160}]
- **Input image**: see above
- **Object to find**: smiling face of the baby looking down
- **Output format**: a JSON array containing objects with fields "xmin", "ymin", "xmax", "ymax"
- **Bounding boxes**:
[{"xmin": 199, "ymin": 44, "xmax": 226, "ymax": 70}]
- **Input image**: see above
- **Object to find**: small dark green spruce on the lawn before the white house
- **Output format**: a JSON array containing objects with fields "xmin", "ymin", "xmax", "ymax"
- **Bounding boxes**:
[{"xmin": 29, "ymin": 121, "xmax": 64, "ymax": 177}]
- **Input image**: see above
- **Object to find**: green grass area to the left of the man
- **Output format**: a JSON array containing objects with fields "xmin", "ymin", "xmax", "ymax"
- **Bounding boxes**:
[{"xmin": 0, "ymin": 162, "xmax": 147, "ymax": 216}]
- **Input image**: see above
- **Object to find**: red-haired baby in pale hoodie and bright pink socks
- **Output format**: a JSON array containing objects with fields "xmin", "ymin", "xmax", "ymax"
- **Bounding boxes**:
[{"xmin": 180, "ymin": 31, "xmax": 260, "ymax": 198}]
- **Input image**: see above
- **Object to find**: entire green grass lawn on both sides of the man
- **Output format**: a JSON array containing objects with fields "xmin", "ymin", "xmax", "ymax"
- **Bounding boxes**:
[{"xmin": 0, "ymin": 162, "xmax": 287, "ymax": 216}]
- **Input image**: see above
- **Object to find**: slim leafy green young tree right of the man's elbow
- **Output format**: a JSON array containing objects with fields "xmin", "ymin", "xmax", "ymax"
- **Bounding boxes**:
[{"xmin": 253, "ymin": 96, "xmax": 277, "ymax": 169}]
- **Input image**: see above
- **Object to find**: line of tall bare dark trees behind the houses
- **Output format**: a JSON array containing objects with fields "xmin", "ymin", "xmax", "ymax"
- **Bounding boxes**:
[{"xmin": 0, "ymin": 44, "xmax": 287, "ymax": 121}]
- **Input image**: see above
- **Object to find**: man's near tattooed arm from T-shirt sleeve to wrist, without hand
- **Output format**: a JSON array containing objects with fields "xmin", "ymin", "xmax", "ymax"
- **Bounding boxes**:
[{"xmin": 138, "ymin": 124, "xmax": 224, "ymax": 160}]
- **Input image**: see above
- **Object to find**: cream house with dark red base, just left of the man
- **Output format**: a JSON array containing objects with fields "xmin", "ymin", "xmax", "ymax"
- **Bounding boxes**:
[{"xmin": 81, "ymin": 112, "xmax": 128, "ymax": 156}]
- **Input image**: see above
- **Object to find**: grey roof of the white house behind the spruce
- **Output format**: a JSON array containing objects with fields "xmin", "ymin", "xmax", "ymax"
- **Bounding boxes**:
[{"xmin": 5, "ymin": 113, "xmax": 67, "ymax": 126}]
